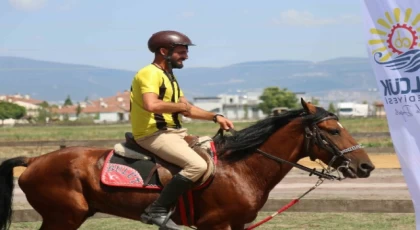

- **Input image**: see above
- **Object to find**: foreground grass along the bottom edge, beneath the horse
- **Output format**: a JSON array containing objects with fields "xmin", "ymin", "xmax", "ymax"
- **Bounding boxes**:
[{"xmin": 11, "ymin": 212, "xmax": 415, "ymax": 230}]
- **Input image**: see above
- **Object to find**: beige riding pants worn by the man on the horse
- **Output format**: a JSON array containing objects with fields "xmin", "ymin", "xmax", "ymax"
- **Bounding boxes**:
[{"xmin": 136, "ymin": 129, "xmax": 207, "ymax": 182}]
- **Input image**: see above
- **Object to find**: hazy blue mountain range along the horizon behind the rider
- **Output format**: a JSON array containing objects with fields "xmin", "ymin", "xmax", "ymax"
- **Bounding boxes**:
[{"xmin": 0, "ymin": 56, "xmax": 378, "ymax": 104}]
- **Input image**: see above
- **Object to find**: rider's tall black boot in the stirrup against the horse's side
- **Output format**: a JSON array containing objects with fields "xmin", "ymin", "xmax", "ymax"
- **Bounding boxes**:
[{"xmin": 141, "ymin": 174, "xmax": 193, "ymax": 230}]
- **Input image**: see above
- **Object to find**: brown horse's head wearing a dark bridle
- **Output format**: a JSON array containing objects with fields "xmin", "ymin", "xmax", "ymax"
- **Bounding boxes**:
[{"xmin": 301, "ymin": 99, "xmax": 375, "ymax": 178}]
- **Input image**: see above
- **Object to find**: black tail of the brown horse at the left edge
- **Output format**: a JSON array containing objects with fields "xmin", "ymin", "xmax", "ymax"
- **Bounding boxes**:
[{"xmin": 0, "ymin": 157, "xmax": 29, "ymax": 230}]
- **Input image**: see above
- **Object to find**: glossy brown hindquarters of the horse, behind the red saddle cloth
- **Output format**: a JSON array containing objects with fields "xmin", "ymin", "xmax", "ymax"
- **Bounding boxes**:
[{"xmin": 15, "ymin": 147, "xmax": 107, "ymax": 229}]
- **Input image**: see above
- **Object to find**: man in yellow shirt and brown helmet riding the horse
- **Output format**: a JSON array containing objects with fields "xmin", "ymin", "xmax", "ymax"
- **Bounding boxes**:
[{"xmin": 131, "ymin": 31, "xmax": 233, "ymax": 229}]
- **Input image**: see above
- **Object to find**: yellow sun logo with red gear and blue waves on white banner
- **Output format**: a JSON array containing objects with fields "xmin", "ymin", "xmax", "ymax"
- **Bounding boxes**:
[{"xmin": 369, "ymin": 8, "xmax": 420, "ymax": 72}]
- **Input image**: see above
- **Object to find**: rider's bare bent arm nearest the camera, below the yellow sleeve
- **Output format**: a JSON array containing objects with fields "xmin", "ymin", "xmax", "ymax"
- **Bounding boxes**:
[{"xmin": 143, "ymin": 93, "xmax": 191, "ymax": 113}]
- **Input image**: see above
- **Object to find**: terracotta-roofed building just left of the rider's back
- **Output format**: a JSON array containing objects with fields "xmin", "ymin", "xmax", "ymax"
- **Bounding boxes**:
[{"xmin": 51, "ymin": 91, "xmax": 130, "ymax": 123}]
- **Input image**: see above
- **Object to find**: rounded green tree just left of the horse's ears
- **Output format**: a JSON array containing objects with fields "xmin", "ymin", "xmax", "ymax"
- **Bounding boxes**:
[{"xmin": 258, "ymin": 87, "xmax": 299, "ymax": 114}]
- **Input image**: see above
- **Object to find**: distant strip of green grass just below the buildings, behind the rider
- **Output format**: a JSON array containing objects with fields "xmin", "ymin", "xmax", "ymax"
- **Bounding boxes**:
[{"xmin": 0, "ymin": 118, "xmax": 390, "ymax": 146}]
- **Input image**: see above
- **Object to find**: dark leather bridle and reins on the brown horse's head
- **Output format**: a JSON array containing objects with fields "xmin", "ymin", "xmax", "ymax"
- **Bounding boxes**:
[{"xmin": 257, "ymin": 114, "xmax": 362, "ymax": 180}]
